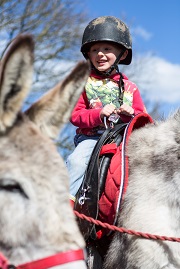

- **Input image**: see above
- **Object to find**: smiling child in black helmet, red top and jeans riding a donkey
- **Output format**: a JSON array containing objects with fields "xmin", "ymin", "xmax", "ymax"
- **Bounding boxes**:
[{"xmin": 67, "ymin": 16, "xmax": 146, "ymax": 200}]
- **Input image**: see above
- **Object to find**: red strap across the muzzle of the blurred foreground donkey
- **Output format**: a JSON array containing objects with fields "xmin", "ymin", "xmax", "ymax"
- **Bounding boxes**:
[{"xmin": 15, "ymin": 249, "xmax": 85, "ymax": 269}]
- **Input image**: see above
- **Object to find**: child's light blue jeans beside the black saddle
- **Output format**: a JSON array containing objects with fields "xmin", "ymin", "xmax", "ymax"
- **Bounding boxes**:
[{"xmin": 66, "ymin": 134, "xmax": 99, "ymax": 196}]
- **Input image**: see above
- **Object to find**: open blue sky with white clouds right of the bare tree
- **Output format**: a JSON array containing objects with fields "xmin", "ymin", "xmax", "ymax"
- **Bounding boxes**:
[{"xmin": 85, "ymin": 0, "xmax": 180, "ymax": 114}]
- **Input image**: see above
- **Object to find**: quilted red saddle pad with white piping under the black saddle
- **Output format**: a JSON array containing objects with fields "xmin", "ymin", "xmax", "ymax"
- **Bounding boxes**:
[{"xmin": 98, "ymin": 113, "xmax": 153, "ymax": 236}]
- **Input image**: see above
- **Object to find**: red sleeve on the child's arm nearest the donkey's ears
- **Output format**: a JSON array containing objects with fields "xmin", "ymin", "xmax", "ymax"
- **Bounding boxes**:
[{"xmin": 70, "ymin": 91, "xmax": 102, "ymax": 128}]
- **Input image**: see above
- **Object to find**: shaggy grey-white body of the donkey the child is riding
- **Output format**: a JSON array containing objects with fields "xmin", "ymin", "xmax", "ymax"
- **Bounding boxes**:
[{"xmin": 104, "ymin": 110, "xmax": 180, "ymax": 269}]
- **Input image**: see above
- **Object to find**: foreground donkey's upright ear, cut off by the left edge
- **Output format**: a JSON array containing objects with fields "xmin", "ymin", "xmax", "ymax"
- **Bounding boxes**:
[{"xmin": 0, "ymin": 34, "xmax": 34, "ymax": 132}]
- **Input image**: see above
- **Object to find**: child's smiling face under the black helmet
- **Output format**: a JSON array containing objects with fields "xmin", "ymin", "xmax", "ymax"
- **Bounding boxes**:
[{"xmin": 88, "ymin": 42, "xmax": 127, "ymax": 73}]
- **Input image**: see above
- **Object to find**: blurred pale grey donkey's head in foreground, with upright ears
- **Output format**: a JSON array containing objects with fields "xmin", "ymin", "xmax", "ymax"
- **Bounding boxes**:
[{"xmin": 0, "ymin": 35, "xmax": 89, "ymax": 269}]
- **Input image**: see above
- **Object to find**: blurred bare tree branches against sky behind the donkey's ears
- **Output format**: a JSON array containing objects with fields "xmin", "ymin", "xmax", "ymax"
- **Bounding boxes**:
[{"xmin": 0, "ymin": 0, "xmax": 86, "ymax": 90}]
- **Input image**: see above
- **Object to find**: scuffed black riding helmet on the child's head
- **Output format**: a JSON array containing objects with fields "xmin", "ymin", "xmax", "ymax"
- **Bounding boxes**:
[{"xmin": 81, "ymin": 16, "xmax": 132, "ymax": 65}]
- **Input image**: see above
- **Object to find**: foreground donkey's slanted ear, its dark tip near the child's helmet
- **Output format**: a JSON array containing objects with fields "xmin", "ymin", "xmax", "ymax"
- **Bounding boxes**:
[{"xmin": 26, "ymin": 61, "xmax": 89, "ymax": 139}]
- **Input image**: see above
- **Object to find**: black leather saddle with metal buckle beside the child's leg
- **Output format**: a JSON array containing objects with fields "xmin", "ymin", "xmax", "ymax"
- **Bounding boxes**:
[{"xmin": 74, "ymin": 123, "xmax": 127, "ymax": 240}]
